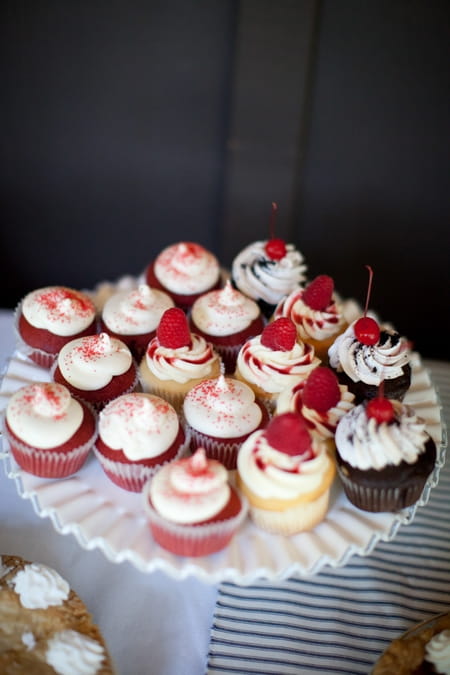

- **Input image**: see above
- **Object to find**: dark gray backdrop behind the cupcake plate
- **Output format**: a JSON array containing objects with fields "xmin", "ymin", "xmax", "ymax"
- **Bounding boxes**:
[{"xmin": 0, "ymin": 0, "xmax": 450, "ymax": 358}]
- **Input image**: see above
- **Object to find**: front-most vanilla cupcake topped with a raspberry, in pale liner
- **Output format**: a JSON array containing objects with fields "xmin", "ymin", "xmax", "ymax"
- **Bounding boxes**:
[{"xmin": 237, "ymin": 412, "xmax": 335, "ymax": 535}]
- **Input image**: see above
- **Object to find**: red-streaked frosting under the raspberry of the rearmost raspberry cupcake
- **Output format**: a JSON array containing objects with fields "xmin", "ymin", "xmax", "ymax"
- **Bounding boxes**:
[{"xmin": 275, "ymin": 288, "xmax": 345, "ymax": 341}]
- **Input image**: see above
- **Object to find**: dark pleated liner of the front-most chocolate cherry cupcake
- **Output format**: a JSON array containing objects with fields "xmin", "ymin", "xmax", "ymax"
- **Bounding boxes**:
[{"xmin": 338, "ymin": 465, "xmax": 426, "ymax": 513}]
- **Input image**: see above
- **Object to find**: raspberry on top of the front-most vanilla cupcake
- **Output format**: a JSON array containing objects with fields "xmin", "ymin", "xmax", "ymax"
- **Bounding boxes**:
[{"xmin": 264, "ymin": 412, "xmax": 313, "ymax": 459}]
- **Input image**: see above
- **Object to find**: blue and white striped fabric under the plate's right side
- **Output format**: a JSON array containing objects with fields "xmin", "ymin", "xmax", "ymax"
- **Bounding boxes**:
[{"xmin": 207, "ymin": 362, "xmax": 450, "ymax": 675}]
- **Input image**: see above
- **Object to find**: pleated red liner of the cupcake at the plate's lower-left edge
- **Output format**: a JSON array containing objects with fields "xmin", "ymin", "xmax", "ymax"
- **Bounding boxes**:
[{"xmin": 3, "ymin": 423, "xmax": 97, "ymax": 478}]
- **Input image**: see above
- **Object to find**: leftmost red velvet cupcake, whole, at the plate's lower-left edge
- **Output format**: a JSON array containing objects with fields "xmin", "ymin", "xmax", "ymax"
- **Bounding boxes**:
[{"xmin": 3, "ymin": 382, "xmax": 97, "ymax": 478}]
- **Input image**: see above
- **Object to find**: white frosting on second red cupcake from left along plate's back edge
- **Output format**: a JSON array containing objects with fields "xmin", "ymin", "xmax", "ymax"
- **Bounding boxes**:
[{"xmin": 102, "ymin": 284, "xmax": 174, "ymax": 335}]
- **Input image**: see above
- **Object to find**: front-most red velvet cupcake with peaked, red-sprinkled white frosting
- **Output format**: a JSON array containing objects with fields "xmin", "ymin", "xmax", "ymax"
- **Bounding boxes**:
[{"xmin": 143, "ymin": 448, "xmax": 247, "ymax": 556}]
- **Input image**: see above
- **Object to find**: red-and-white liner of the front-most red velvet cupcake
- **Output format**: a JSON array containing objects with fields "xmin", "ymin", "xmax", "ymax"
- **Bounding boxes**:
[{"xmin": 143, "ymin": 482, "xmax": 248, "ymax": 557}]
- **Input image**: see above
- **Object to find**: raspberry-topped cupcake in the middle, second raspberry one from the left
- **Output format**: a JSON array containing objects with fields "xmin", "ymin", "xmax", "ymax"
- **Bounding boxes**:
[{"xmin": 235, "ymin": 317, "xmax": 320, "ymax": 410}]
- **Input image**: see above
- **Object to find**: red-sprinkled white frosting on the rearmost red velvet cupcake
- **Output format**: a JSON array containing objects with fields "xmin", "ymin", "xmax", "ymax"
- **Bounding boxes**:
[{"xmin": 153, "ymin": 242, "xmax": 220, "ymax": 295}]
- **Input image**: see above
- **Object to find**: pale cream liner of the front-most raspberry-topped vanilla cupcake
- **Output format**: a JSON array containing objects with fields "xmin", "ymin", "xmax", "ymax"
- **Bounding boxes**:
[{"xmin": 246, "ymin": 490, "xmax": 330, "ymax": 536}]
